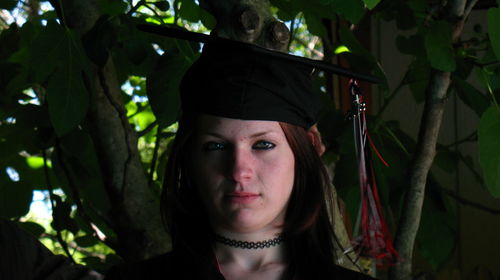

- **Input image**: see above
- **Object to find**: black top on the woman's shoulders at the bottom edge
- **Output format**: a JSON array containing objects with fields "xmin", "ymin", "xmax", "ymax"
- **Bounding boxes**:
[{"xmin": 105, "ymin": 250, "xmax": 373, "ymax": 280}]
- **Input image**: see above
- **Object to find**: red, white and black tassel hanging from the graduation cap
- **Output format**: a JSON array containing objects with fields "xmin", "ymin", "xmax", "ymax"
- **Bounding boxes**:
[{"xmin": 349, "ymin": 80, "xmax": 398, "ymax": 265}]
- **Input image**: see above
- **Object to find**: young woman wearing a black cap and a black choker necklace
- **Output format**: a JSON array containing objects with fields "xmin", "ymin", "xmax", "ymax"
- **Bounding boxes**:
[{"xmin": 106, "ymin": 31, "xmax": 376, "ymax": 280}]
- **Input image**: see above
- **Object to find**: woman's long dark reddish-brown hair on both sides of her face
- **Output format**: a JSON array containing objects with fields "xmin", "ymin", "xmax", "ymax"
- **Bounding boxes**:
[{"xmin": 161, "ymin": 115, "xmax": 334, "ymax": 278}]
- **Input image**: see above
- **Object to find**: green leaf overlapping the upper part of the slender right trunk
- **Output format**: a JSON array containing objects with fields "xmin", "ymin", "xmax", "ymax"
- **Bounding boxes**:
[{"xmin": 424, "ymin": 21, "xmax": 456, "ymax": 72}]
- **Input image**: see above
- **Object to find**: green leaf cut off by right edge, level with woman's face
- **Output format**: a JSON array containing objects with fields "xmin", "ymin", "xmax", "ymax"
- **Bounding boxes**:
[{"xmin": 478, "ymin": 106, "xmax": 500, "ymax": 197}]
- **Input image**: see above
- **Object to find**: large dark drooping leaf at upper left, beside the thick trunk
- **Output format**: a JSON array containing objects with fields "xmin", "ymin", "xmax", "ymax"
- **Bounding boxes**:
[{"xmin": 31, "ymin": 21, "xmax": 89, "ymax": 136}]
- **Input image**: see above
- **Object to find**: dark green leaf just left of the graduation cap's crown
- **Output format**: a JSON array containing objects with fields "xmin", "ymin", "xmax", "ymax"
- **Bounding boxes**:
[{"xmin": 146, "ymin": 52, "xmax": 190, "ymax": 127}]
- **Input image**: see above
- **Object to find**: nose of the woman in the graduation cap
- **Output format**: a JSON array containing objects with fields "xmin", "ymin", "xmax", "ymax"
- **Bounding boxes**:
[{"xmin": 228, "ymin": 148, "xmax": 254, "ymax": 184}]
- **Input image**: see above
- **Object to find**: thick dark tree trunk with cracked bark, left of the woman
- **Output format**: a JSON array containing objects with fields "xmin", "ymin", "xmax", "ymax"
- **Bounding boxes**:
[{"xmin": 59, "ymin": 0, "xmax": 169, "ymax": 261}]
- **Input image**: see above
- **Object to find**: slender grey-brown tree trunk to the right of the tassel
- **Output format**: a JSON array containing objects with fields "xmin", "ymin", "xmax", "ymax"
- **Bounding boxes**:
[{"xmin": 389, "ymin": 0, "xmax": 477, "ymax": 280}]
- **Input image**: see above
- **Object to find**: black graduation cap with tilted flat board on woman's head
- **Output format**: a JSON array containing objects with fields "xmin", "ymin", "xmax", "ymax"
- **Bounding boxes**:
[{"xmin": 138, "ymin": 25, "xmax": 380, "ymax": 129}]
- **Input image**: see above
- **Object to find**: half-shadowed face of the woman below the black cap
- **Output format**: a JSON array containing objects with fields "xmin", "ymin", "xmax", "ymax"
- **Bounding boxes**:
[{"xmin": 191, "ymin": 115, "xmax": 295, "ymax": 233}]
